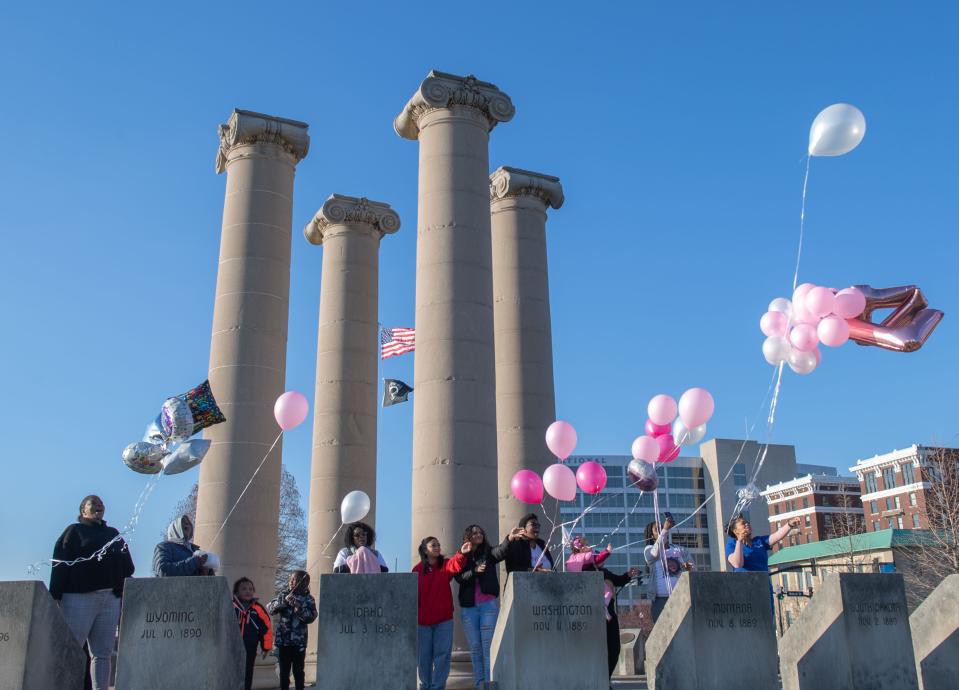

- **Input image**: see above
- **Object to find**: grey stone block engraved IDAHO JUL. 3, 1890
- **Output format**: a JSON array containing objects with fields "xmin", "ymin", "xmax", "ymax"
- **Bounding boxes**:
[{"xmin": 316, "ymin": 573, "xmax": 417, "ymax": 690}]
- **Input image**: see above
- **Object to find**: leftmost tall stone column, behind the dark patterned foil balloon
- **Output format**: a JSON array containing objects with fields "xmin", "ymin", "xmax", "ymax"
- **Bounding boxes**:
[{"xmin": 195, "ymin": 110, "xmax": 310, "ymax": 596}]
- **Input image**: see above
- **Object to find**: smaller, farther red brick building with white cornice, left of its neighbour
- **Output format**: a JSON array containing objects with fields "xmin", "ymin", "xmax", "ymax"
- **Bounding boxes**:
[{"xmin": 757, "ymin": 474, "xmax": 865, "ymax": 550}]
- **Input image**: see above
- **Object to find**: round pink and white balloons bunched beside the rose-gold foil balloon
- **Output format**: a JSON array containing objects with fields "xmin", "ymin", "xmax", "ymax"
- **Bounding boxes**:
[{"xmin": 759, "ymin": 283, "xmax": 866, "ymax": 374}]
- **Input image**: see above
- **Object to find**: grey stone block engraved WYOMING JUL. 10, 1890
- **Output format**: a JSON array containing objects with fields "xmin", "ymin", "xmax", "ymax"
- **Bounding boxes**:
[{"xmin": 116, "ymin": 577, "xmax": 246, "ymax": 690}]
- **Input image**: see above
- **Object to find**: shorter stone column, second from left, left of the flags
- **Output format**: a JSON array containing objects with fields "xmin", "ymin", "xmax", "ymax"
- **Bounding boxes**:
[{"xmin": 304, "ymin": 194, "xmax": 400, "ymax": 583}]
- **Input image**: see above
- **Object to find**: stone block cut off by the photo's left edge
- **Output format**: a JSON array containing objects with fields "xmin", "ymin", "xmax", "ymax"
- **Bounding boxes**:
[{"xmin": 0, "ymin": 566, "xmax": 86, "ymax": 690}]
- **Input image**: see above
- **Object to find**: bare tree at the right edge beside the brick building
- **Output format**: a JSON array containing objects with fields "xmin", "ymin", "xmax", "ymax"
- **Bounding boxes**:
[{"xmin": 903, "ymin": 448, "xmax": 959, "ymax": 608}]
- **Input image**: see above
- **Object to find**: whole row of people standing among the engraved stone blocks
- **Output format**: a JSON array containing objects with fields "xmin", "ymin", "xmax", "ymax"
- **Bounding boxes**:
[{"xmin": 50, "ymin": 495, "xmax": 798, "ymax": 690}]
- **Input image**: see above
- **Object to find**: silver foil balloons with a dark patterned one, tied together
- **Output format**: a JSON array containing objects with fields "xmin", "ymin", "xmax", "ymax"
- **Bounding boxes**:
[{"xmin": 121, "ymin": 381, "xmax": 226, "ymax": 474}]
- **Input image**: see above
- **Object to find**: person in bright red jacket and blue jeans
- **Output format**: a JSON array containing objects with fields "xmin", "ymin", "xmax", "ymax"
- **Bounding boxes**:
[{"xmin": 413, "ymin": 537, "xmax": 473, "ymax": 690}]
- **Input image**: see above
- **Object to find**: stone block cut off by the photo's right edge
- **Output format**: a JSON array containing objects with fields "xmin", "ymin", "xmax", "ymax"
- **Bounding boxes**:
[{"xmin": 909, "ymin": 575, "xmax": 959, "ymax": 690}]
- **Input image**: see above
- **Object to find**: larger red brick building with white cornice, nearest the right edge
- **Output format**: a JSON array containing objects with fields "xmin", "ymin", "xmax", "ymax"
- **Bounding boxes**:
[{"xmin": 849, "ymin": 445, "xmax": 942, "ymax": 532}]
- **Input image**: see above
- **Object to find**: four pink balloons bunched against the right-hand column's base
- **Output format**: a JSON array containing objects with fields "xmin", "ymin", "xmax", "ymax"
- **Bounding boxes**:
[{"xmin": 510, "ymin": 420, "xmax": 606, "ymax": 504}]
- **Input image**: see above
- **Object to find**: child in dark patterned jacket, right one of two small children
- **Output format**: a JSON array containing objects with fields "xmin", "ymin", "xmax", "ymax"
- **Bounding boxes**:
[{"xmin": 266, "ymin": 570, "xmax": 316, "ymax": 690}]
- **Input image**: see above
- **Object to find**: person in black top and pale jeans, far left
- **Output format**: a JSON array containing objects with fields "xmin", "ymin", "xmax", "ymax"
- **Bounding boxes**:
[{"xmin": 50, "ymin": 496, "xmax": 134, "ymax": 690}]
